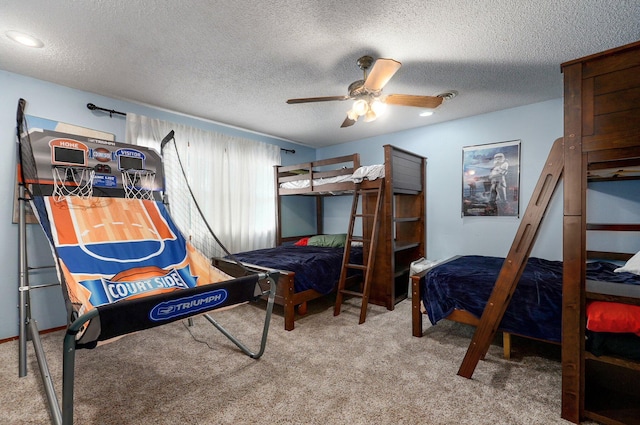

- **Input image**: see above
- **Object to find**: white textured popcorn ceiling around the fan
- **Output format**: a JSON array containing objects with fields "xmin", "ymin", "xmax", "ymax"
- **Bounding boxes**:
[{"xmin": 0, "ymin": 0, "xmax": 640, "ymax": 147}]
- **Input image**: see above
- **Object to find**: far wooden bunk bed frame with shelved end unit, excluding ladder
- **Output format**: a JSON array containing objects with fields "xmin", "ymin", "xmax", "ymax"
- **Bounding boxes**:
[{"xmin": 214, "ymin": 145, "xmax": 426, "ymax": 330}]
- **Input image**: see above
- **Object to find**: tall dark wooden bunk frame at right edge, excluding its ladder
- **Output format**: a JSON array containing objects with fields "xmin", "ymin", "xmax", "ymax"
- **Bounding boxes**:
[{"xmin": 562, "ymin": 42, "xmax": 640, "ymax": 424}]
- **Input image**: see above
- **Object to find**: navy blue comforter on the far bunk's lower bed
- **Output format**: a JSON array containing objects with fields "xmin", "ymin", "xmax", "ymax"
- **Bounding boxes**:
[{"xmin": 234, "ymin": 245, "xmax": 362, "ymax": 294}]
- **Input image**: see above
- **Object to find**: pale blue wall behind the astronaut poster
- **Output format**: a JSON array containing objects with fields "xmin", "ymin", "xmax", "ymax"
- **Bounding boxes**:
[{"xmin": 318, "ymin": 98, "xmax": 563, "ymax": 259}]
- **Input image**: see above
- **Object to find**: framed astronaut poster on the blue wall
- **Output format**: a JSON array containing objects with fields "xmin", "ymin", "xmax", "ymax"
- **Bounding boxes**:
[{"xmin": 462, "ymin": 140, "xmax": 520, "ymax": 217}]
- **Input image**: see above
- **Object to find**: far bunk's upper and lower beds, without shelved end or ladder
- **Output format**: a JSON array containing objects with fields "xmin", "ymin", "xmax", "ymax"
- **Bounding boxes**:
[{"xmin": 218, "ymin": 154, "xmax": 386, "ymax": 331}]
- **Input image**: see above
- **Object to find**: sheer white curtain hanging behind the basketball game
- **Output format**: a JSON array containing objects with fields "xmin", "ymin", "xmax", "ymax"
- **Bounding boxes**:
[{"xmin": 126, "ymin": 113, "xmax": 280, "ymax": 256}]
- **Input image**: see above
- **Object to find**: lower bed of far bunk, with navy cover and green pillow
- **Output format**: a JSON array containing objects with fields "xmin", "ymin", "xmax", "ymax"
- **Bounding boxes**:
[{"xmin": 213, "ymin": 235, "xmax": 363, "ymax": 331}]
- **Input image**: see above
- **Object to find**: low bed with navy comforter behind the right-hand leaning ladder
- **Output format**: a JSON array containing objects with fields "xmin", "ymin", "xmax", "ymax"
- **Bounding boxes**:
[{"xmin": 411, "ymin": 255, "xmax": 640, "ymax": 358}]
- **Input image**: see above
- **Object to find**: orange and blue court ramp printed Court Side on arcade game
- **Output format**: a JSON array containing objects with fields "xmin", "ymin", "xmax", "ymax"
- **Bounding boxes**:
[{"xmin": 44, "ymin": 197, "xmax": 231, "ymax": 306}]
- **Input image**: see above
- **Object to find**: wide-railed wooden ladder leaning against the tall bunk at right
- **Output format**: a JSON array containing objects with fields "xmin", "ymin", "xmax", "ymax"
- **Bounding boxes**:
[{"xmin": 458, "ymin": 138, "xmax": 564, "ymax": 378}]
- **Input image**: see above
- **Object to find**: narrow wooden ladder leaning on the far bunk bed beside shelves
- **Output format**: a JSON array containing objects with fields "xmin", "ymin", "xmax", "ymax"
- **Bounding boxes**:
[{"xmin": 333, "ymin": 179, "xmax": 384, "ymax": 324}]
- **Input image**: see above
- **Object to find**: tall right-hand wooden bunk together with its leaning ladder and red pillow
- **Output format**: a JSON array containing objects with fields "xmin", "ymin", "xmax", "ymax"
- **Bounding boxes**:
[{"xmin": 430, "ymin": 42, "xmax": 640, "ymax": 425}]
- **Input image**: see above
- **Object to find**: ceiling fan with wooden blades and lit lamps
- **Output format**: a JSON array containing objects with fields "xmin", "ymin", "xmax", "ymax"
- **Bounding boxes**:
[{"xmin": 287, "ymin": 56, "xmax": 446, "ymax": 127}]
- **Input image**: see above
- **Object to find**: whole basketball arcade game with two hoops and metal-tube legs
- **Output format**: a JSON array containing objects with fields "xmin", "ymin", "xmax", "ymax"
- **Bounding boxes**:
[{"xmin": 17, "ymin": 99, "xmax": 277, "ymax": 425}]
